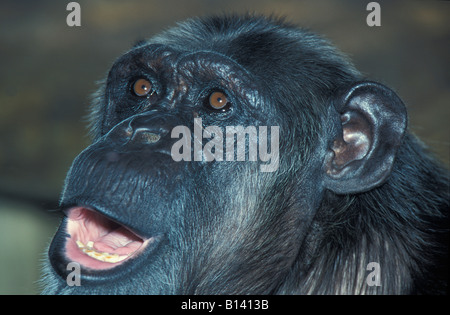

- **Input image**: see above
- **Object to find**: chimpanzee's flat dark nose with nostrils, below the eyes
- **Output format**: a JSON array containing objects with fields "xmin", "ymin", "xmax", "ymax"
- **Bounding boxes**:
[{"xmin": 108, "ymin": 114, "xmax": 169, "ymax": 145}]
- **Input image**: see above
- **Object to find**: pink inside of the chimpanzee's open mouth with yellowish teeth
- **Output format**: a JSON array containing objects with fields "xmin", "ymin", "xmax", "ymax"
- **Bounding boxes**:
[{"xmin": 65, "ymin": 207, "xmax": 154, "ymax": 270}]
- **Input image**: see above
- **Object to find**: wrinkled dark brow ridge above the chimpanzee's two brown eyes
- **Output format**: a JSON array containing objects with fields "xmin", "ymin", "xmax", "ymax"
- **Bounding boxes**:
[{"xmin": 110, "ymin": 44, "xmax": 257, "ymax": 97}]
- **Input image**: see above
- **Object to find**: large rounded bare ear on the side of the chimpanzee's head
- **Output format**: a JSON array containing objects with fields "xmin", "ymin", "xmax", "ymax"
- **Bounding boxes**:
[{"xmin": 324, "ymin": 82, "xmax": 407, "ymax": 194}]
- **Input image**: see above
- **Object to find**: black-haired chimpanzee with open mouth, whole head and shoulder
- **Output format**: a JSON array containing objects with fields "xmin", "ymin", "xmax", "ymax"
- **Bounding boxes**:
[{"xmin": 43, "ymin": 14, "xmax": 449, "ymax": 294}]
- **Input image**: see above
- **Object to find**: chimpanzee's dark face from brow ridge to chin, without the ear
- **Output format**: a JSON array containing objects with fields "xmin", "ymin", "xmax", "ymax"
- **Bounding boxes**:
[{"xmin": 46, "ymin": 39, "xmax": 302, "ymax": 293}]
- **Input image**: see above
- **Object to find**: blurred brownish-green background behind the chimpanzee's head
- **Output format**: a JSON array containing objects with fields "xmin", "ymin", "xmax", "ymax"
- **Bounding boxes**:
[{"xmin": 0, "ymin": 0, "xmax": 450, "ymax": 294}]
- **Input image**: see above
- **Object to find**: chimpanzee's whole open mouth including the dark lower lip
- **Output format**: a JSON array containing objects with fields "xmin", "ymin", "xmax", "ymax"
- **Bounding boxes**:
[{"xmin": 49, "ymin": 206, "xmax": 162, "ymax": 280}]
